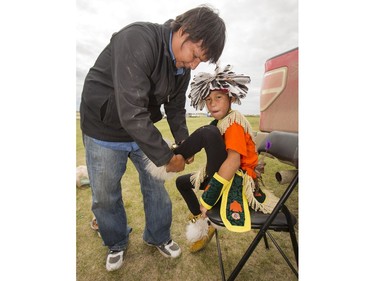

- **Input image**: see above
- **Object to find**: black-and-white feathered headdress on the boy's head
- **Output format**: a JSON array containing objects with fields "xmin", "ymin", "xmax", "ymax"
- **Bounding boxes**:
[{"xmin": 189, "ymin": 64, "xmax": 251, "ymax": 110}]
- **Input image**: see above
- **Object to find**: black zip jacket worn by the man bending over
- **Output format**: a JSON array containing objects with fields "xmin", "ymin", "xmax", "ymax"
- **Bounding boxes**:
[{"xmin": 80, "ymin": 20, "xmax": 190, "ymax": 166}]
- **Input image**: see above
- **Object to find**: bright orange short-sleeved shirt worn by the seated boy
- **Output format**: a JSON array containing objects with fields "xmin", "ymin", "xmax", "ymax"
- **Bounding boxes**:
[{"xmin": 224, "ymin": 123, "xmax": 258, "ymax": 179}]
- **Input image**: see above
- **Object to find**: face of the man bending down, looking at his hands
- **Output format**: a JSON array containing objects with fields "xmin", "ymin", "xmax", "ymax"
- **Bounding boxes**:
[{"xmin": 172, "ymin": 28, "xmax": 208, "ymax": 70}]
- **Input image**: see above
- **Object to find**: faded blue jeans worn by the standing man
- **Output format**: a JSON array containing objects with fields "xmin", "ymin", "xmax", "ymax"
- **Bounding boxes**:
[{"xmin": 83, "ymin": 135, "xmax": 172, "ymax": 251}]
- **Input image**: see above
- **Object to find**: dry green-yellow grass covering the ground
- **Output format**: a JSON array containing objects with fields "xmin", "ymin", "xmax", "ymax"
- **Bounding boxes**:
[{"xmin": 76, "ymin": 117, "xmax": 298, "ymax": 281}]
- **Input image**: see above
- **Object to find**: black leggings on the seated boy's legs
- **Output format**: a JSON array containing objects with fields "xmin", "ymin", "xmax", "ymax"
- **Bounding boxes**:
[{"xmin": 174, "ymin": 125, "xmax": 227, "ymax": 216}]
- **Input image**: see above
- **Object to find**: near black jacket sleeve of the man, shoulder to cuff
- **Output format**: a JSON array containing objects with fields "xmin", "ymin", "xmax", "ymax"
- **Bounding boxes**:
[{"xmin": 111, "ymin": 25, "xmax": 173, "ymax": 166}]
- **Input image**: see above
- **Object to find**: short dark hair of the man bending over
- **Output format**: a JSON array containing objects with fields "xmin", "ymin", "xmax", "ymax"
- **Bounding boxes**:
[{"xmin": 171, "ymin": 5, "xmax": 226, "ymax": 63}]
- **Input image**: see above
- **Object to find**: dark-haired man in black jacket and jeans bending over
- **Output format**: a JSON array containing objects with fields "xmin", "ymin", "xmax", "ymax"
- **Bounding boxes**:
[{"xmin": 80, "ymin": 6, "xmax": 225, "ymax": 271}]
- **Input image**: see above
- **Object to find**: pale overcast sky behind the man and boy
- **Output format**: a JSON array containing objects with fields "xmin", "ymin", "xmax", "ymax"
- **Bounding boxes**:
[{"xmin": 76, "ymin": 0, "xmax": 298, "ymax": 114}]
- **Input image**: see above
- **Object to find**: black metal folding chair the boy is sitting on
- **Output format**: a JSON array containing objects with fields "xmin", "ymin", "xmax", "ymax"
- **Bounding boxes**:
[{"xmin": 207, "ymin": 131, "xmax": 298, "ymax": 280}]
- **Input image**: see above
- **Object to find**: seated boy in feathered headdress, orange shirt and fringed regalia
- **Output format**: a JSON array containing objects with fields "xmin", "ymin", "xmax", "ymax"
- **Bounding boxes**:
[{"xmin": 174, "ymin": 65, "xmax": 273, "ymax": 252}]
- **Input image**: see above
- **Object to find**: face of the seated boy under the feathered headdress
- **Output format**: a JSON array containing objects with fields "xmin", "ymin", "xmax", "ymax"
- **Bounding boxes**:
[{"xmin": 205, "ymin": 90, "xmax": 231, "ymax": 120}]
